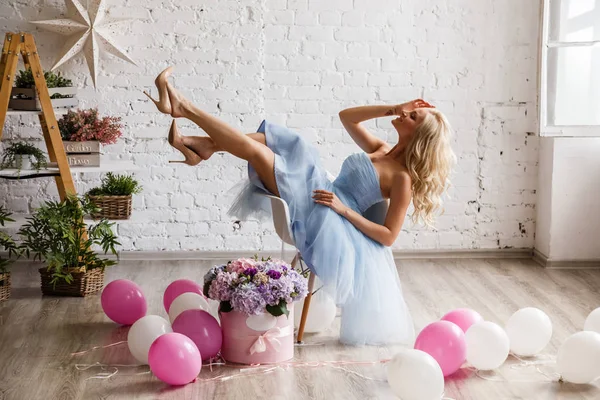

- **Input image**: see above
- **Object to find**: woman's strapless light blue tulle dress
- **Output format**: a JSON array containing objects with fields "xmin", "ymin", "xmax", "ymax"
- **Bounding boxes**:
[{"xmin": 228, "ymin": 121, "xmax": 415, "ymax": 345}]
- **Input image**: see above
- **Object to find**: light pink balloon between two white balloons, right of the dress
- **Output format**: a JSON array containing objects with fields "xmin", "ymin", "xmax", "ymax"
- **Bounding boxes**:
[{"xmin": 415, "ymin": 321, "xmax": 467, "ymax": 376}]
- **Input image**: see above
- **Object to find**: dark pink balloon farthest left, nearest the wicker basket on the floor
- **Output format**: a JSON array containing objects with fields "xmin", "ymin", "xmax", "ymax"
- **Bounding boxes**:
[{"xmin": 100, "ymin": 279, "xmax": 148, "ymax": 325}]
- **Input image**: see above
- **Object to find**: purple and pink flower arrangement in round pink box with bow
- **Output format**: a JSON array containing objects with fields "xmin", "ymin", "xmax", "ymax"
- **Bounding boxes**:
[{"xmin": 203, "ymin": 257, "xmax": 308, "ymax": 364}]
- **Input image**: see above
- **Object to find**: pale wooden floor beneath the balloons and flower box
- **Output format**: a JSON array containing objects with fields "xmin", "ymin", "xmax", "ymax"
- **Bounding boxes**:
[{"xmin": 0, "ymin": 260, "xmax": 600, "ymax": 400}]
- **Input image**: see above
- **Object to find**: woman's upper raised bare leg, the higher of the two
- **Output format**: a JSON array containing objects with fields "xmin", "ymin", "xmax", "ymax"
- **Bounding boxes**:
[{"xmin": 166, "ymin": 83, "xmax": 279, "ymax": 196}]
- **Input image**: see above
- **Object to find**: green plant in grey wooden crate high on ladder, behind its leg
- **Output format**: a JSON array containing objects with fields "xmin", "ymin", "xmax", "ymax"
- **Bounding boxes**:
[{"xmin": 8, "ymin": 68, "xmax": 78, "ymax": 111}]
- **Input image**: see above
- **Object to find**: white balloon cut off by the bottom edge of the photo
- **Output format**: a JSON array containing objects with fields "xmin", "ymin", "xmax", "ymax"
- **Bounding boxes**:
[{"xmin": 386, "ymin": 349, "xmax": 444, "ymax": 400}]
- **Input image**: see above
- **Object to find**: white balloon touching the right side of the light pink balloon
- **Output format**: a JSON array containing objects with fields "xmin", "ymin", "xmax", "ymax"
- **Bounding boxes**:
[{"xmin": 465, "ymin": 321, "xmax": 510, "ymax": 371}]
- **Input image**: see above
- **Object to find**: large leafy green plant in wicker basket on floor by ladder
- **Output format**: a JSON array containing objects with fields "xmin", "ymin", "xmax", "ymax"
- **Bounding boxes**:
[{"xmin": 18, "ymin": 194, "xmax": 120, "ymax": 296}]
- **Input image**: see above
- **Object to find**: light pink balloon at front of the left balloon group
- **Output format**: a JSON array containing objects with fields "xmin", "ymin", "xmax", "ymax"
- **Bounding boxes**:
[{"xmin": 148, "ymin": 332, "xmax": 202, "ymax": 385}]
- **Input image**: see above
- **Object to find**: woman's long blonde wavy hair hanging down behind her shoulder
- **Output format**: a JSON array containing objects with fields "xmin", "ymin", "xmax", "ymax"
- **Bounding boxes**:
[{"xmin": 405, "ymin": 109, "xmax": 456, "ymax": 226}]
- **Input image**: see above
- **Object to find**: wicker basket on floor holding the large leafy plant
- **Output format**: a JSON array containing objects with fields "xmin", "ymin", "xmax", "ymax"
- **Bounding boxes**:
[{"xmin": 39, "ymin": 268, "xmax": 104, "ymax": 297}]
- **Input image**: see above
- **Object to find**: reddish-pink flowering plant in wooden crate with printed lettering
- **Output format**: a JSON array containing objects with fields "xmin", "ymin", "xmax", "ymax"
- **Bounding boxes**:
[{"xmin": 58, "ymin": 108, "xmax": 123, "ymax": 167}]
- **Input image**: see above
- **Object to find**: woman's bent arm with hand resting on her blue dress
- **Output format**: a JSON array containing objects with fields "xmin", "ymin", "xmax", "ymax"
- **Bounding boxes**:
[{"xmin": 313, "ymin": 173, "xmax": 411, "ymax": 246}]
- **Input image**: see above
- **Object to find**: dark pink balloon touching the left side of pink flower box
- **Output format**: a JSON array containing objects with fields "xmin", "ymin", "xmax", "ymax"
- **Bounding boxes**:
[{"xmin": 173, "ymin": 310, "xmax": 223, "ymax": 361}]
